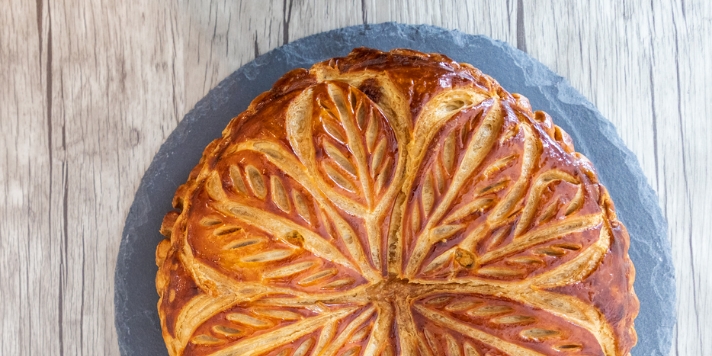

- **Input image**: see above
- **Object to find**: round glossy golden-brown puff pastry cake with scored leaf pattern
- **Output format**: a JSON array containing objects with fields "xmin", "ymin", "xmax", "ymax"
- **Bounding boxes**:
[{"xmin": 156, "ymin": 48, "xmax": 638, "ymax": 356}]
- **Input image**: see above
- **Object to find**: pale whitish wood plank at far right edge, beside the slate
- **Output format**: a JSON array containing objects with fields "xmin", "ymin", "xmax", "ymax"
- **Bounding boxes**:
[{"xmin": 651, "ymin": 1, "xmax": 712, "ymax": 355}]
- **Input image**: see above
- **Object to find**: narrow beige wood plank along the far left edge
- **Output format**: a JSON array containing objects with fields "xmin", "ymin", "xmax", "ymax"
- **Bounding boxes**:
[{"xmin": 0, "ymin": 1, "xmax": 57, "ymax": 355}]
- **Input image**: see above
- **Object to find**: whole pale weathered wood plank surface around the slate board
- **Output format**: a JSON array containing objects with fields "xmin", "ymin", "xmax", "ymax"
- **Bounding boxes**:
[{"xmin": 0, "ymin": 0, "xmax": 712, "ymax": 356}]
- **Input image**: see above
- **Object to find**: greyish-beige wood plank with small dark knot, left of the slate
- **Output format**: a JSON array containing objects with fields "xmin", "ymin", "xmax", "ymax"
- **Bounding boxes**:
[{"xmin": 38, "ymin": 1, "xmax": 186, "ymax": 355}]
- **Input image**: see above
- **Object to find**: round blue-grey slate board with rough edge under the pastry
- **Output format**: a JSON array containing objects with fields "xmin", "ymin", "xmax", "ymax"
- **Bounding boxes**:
[{"xmin": 114, "ymin": 23, "xmax": 675, "ymax": 356}]
